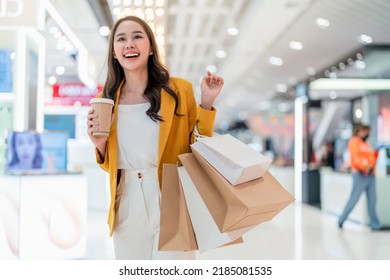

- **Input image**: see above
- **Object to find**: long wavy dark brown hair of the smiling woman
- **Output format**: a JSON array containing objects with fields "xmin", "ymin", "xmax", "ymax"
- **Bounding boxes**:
[{"xmin": 103, "ymin": 16, "xmax": 180, "ymax": 121}]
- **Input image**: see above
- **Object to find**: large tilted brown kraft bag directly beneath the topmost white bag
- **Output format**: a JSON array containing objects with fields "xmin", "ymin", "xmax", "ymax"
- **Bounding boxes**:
[{"xmin": 179, "ymin": 150, "xmax": 295, "ymax": 232}]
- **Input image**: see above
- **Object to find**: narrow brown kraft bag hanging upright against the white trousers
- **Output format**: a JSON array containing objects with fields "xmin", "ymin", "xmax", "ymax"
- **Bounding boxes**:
[{"xmin": 158, "ymin": 164, "xmax": 198, "ymax": 251}]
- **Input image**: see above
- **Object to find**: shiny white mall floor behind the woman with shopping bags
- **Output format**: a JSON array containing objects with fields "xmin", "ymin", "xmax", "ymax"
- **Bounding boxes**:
[{"xmin": 86, "ymin": 204, "xmax": 390, "ymax": 260}]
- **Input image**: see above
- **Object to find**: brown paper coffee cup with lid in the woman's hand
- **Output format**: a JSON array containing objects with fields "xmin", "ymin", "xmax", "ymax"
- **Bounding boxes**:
[{"xmin": 89, "ymin": 98, "xmax": 114, "ymax": 136}]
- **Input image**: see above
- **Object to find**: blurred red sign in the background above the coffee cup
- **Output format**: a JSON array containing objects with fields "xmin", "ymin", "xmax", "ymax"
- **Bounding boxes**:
[{"xmin": 46, "ymin": 83, "xmax": 103, "ymax": 106}]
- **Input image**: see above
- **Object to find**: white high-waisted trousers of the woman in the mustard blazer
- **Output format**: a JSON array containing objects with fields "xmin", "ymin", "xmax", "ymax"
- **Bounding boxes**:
[{"xmin": 113, "ymin": 166, "xmax": 196, "ymax": 260}]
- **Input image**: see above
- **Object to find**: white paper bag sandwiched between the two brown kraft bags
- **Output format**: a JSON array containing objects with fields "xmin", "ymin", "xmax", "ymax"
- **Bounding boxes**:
[{"xmin": 178, "ymin": 166, "xmax": 254, "ymax": 253}]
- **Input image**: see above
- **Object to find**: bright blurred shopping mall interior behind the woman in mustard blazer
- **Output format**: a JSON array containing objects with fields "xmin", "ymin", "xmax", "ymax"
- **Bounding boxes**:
[{"xmin": 0, "ymin": 0, "xmax": 390, "ymax": 260}]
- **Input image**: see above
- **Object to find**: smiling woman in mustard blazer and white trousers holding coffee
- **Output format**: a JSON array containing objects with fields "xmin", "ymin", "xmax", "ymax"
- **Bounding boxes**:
[{"xmin": 87, "ymin": 16, "xmax": 223, "ymax": 259}]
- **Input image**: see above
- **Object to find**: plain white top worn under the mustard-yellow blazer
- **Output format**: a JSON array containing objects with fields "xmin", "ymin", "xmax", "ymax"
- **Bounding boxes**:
[{"xmin": 117, "ymin": 103, "xmax": 160, "ymax": 170}]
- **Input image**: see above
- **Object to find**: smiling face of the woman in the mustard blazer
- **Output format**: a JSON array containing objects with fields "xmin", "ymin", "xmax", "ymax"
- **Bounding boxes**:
[{"xmin": 113, "ymin": 20, "xmax": 152, "ymax": 71}]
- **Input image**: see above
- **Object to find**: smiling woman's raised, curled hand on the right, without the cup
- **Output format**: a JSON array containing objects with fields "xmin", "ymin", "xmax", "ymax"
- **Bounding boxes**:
[{"xmin": 200, "ymin": 72, "xmax": 224, "ymax": 110}]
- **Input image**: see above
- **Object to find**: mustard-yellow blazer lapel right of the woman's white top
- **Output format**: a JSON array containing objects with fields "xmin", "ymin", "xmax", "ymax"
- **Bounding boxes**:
[{"xmin": 158, "ymin": 85, "xmax": 175, "ymax": 162}]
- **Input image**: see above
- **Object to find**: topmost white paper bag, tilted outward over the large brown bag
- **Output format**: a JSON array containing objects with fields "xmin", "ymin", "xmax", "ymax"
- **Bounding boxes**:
[{"xmin": 191, "ymin": 134, "xmax": 272, "ymax": 185}]
